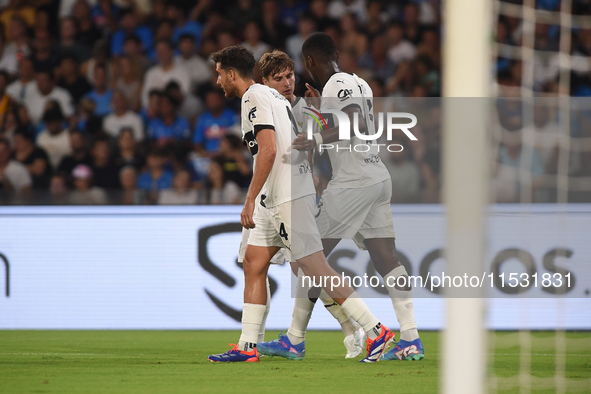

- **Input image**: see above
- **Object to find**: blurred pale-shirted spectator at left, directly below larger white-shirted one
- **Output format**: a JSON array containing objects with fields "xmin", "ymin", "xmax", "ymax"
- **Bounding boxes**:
[{"xmin": 37, "ymin": 105, "xmax": 72, "ymax": 168}]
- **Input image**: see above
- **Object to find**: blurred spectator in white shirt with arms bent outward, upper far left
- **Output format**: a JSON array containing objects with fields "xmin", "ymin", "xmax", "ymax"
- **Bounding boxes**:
[{"xmin": 25, "ymin": 69, "xmax": 74, "ymax": 125}]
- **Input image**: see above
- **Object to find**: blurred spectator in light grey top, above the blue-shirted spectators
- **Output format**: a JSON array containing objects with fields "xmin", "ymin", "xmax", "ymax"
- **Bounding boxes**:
[{"xmin": 142, "ymin": 39, "xmax": 191, "ymax": 107}]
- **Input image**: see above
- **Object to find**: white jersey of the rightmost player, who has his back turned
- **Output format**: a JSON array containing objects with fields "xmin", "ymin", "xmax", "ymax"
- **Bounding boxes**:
[{"xmin": 320, "ymin": 72, "xmax": 390, "ymax": 188}]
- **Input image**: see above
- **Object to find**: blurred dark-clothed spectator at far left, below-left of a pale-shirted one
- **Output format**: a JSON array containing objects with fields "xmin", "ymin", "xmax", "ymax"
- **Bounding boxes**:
[{"xmin": 13, "ymin": 127, "xmax": 52, "ymax": 189}]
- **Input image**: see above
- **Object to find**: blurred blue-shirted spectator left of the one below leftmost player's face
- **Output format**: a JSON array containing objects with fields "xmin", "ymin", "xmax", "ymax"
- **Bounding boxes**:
[{"xmin": 148, "ymin": 93, "xmax": 191, "ymax": 146}]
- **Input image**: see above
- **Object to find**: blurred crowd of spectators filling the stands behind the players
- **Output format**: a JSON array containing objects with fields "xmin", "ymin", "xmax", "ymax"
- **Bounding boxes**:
[{"xmin": 0, "ymin": 0, "xmax": 591, "ymax": 205}]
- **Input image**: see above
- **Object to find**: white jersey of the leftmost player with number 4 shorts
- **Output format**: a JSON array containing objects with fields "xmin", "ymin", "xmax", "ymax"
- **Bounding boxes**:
[{"xmin": 242, "ymin": 84, "xmax": 316, "ymax": 208}]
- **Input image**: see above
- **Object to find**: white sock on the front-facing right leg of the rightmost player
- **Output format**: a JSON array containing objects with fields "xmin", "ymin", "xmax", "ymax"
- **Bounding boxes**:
[{"xmin": 384, "ymin": 265, "xmax": 419, "ymax": 342}]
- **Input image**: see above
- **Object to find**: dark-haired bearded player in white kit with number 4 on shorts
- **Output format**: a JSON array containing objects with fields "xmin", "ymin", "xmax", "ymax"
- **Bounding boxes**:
[{"xmin": 208, "ymin": 46, "xmax": 394, "ymax": 362}]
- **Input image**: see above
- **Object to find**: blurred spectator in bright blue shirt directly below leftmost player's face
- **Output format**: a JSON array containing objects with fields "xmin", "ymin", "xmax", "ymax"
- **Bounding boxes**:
[{"xmin": 193, "ymin": 89, "xmax": 238, "ymax": 157}]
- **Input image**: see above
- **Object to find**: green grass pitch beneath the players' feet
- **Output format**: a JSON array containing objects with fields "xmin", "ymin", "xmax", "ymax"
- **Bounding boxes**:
[{"xmin": 0, "ymin": 331, "xmax": 591, "ymax": 393}]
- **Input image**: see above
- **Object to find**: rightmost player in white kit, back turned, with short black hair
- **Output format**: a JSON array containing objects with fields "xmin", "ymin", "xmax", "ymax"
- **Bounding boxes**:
[{"xmin": 268, "ymin": 33, "xmax": 425, "ymax": 360}]
